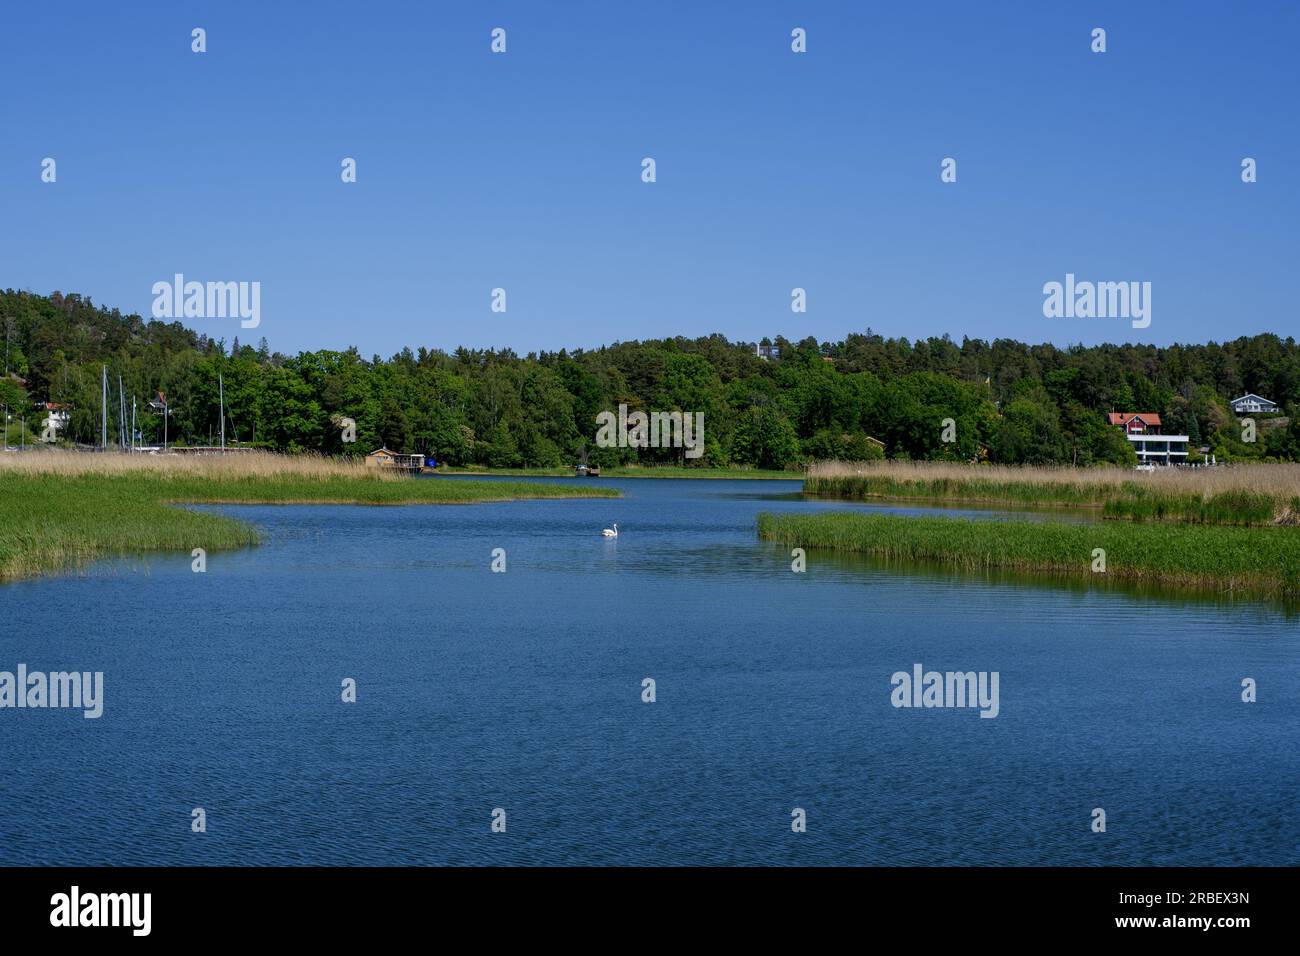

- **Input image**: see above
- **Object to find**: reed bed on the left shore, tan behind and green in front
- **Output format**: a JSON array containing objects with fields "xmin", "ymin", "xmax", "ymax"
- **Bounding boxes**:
[{"xmin": 0, "ymin": 451, "xmax": 618, "ymax": 581}]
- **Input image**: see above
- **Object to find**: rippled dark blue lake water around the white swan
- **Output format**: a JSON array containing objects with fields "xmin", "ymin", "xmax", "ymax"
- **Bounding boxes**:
[{"xmin": 0, "ymin": 479, "xmax": 1300, "ymax": 865}]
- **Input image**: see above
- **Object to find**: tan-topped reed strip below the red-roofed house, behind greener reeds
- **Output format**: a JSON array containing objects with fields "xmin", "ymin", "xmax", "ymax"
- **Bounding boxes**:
[{"xmin": 803, "ymin": 462, "xmax": 1300, "ymax": 525}]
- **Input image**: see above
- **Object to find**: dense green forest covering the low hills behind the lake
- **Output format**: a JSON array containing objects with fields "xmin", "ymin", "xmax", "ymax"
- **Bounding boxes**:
[{"xmin": 0, "ymin": 290, "xmax": 1300, "ymax": 468}]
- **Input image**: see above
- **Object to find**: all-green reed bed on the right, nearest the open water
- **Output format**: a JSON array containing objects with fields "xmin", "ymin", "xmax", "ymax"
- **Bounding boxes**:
[{"xmin": 758, "ymin": 511, "xmax": 1300, "ymax": 600}]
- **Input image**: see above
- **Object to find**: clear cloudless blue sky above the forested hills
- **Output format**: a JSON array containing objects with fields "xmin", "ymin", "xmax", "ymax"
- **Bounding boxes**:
[{"xmin": 0, "ymin": 0, "xmax": 1300, "ymax": 356}]
